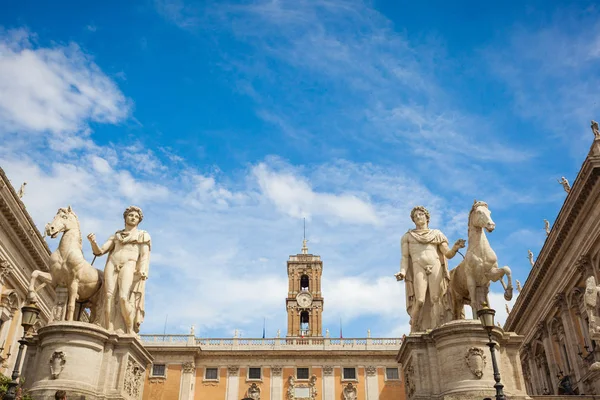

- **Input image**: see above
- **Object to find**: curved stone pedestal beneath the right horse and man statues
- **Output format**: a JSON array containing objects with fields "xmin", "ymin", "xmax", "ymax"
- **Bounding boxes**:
[{"xmin": 397, "ymin": 320, "xmax": 530, "ymax": 400}]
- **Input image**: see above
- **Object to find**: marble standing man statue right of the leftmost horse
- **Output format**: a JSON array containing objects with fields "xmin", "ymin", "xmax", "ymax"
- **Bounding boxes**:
[{"xmin": 87, "ymin": 206, "xmax": 150, "ymax": 333}]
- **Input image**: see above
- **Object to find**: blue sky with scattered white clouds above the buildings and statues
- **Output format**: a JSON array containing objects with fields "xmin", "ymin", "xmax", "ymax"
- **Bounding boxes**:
[{"xmin": 0, "ymin": 0, "xmax": 600, "ymax": 337}]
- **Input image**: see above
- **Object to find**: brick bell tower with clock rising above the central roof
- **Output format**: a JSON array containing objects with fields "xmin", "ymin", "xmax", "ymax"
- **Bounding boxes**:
[{"xmin": 285, "ymin": 238, "xmax": 323, "ymax": 337}]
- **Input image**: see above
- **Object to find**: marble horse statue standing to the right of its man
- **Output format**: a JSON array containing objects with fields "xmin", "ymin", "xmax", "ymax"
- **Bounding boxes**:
[{"xmin": 449, "ymin": 200, "xmax": 513, "ymax": 319}]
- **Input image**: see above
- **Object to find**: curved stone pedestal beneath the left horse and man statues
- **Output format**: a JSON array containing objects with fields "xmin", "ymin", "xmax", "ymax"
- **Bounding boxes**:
[{"xmin": 24, "ymin": 321, "xmax": 152, "ymax": 400}]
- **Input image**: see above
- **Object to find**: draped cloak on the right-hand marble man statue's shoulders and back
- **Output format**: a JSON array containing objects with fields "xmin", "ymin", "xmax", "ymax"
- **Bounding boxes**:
[{"xmin": 404, "ymin": 229, "xmax": 452, "ymax": 330}]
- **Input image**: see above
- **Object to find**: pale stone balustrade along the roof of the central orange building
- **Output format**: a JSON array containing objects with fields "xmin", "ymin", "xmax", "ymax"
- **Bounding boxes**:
[{"xmin": 140, "ymin": 335, "xmax": 402, "ymax": 351}]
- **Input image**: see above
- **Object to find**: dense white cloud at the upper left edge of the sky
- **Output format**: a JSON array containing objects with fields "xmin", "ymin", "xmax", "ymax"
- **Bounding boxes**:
[{"xmin": 0, "ymin": 30, "xmax": 131, "ymax": 141}]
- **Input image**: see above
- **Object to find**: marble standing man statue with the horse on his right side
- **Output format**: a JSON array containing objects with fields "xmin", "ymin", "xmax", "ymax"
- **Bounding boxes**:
[{"xmin": 395, "ymin": 206, "xmax": 465, "ymax": 332}]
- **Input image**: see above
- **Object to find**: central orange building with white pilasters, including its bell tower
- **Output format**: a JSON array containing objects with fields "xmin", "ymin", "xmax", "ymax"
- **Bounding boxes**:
[{"xmin": 141, "ymin": 241, "xmax": 405, "ymax": 400}]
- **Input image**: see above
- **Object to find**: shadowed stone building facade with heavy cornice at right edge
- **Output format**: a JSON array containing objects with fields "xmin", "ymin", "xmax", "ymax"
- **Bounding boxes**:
[{"xmin": 504, "ymin": 132, "xmax": 600, "ymax": 395}]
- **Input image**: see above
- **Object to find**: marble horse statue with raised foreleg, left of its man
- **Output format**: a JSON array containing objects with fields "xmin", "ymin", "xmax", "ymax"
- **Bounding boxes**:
[{"xmin": 29, "ymin": 206, "xmax": 103, "ymax": 323}]
